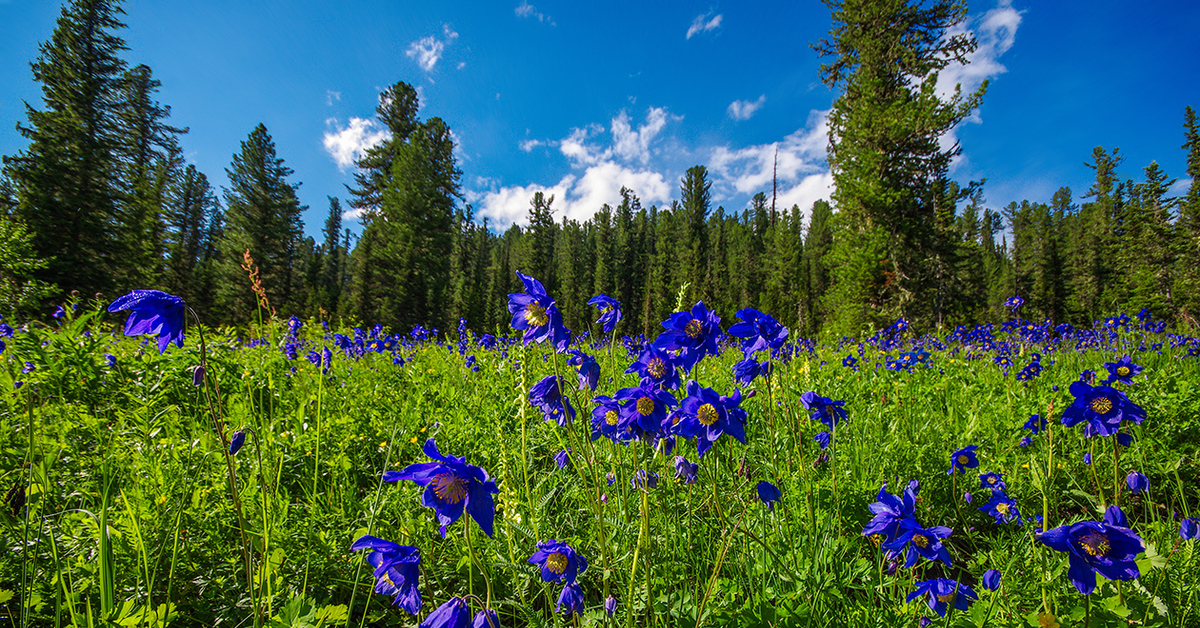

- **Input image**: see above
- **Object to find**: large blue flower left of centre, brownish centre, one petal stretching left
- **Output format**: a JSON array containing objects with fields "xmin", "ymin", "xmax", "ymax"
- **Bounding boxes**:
[{"xmin": 383, "ymin": 438, "xmax": 500, "ymax": 538}]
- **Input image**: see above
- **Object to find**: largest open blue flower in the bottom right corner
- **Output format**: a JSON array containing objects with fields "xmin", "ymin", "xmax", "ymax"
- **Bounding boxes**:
[{"xmin": 1037, "ymin": 506, "xmax": 1145, "ymax": 596}]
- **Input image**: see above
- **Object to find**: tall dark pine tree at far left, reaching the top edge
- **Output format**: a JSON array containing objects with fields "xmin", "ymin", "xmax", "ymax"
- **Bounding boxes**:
[{"xmin": 5, "ymin": 0, "xmax": 126, "ymax": 300}]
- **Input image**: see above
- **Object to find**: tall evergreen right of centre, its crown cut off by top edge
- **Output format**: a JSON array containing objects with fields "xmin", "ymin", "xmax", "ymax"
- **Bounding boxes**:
[{"xmin": 815, "ymin": 0, "xmax": 986, "ymax": 333}]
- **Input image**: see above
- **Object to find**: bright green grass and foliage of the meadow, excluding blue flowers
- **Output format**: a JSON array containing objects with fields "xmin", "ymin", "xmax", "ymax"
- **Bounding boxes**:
[{"xmin": 0, "ymin": 303, "xmax": 1200, "ymax": 627}]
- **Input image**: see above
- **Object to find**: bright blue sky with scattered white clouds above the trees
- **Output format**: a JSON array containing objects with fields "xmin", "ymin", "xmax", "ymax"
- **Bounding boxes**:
[{"xmin": 0, "ymin": 0, "xmax": 1200, "ymax": 240}]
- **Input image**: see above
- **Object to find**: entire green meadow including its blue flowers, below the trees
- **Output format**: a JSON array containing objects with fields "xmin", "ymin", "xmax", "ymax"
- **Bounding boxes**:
[{"xmin": 0, "ymin": 281, "xmax": 1200, "ymax": 628}]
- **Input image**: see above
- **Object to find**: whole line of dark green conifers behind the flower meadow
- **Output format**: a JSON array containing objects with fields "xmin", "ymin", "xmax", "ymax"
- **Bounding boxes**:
[{"xmin": 0, "ymin": 0, "xmax": 1200, "ymax": 335}]
